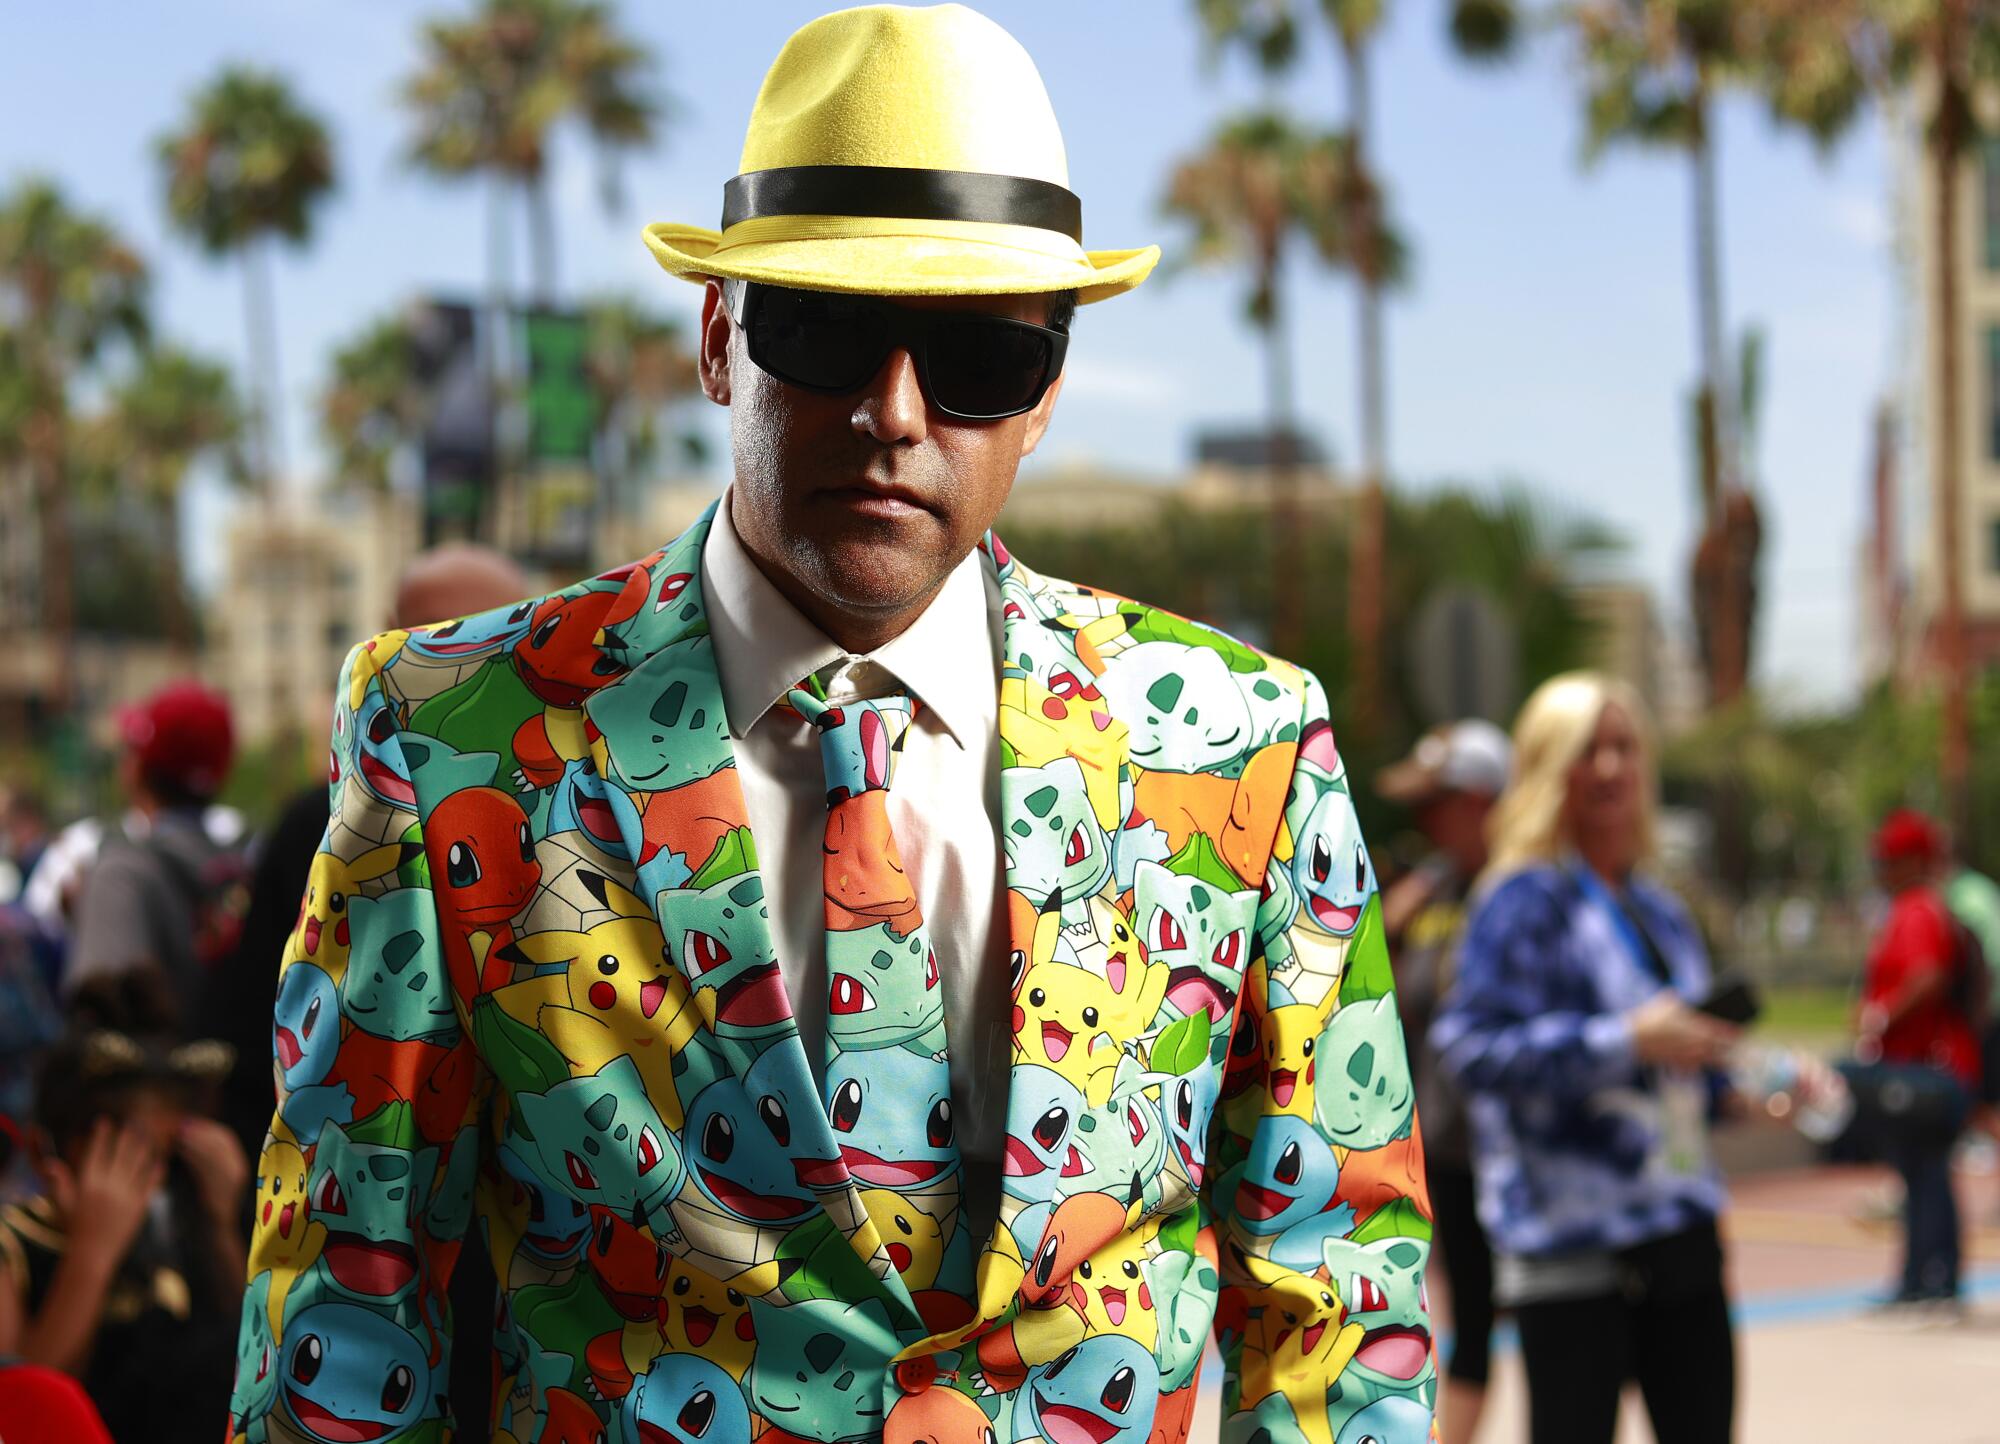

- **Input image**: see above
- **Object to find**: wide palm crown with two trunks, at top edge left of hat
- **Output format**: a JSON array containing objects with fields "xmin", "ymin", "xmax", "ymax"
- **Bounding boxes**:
[{"xmin": 402, "ymin": 0, "xmax": 664, "ymax": 306}]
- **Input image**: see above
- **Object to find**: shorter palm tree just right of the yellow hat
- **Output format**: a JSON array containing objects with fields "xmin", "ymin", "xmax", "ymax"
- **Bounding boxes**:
[{"xmin": 1164, "ymin": 110, "xmax": 1402, "ymax": 652}]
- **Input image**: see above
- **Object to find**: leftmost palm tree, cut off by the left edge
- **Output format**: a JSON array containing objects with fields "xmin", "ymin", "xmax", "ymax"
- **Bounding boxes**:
[{"xmin": 0, "ymin": 178, "xmax": 146, "ymax": 712}]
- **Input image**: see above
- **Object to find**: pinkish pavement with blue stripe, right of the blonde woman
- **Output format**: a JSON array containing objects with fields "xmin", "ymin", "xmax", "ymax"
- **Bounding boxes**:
[{"xmin": 1190, "ymin": 1166, "xmax": 2000, "ymax": 1444}]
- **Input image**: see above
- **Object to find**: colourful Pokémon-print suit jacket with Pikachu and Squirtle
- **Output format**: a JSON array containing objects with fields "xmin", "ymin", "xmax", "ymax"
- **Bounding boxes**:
[{"xmin": 230, "ymin": 504, "xmax": 1436, "ymax": 1444}]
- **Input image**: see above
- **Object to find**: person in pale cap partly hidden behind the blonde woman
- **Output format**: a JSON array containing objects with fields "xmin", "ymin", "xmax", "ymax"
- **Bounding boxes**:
[{"xmin": 1376, "ymin": 718, "xmax": 1512, "ymax": 1444}]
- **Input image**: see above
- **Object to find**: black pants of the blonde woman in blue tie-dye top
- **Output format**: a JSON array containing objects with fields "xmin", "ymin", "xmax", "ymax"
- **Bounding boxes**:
[{"xmin": 1514, "ymin": 1224, "xmax": 1736, "ymax": 1444}]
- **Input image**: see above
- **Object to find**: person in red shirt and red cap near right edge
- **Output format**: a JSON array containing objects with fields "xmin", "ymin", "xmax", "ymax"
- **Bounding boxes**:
[{"xmin": 1854, "ymin": 810, "xmax": 1980, "ymax": 1306}]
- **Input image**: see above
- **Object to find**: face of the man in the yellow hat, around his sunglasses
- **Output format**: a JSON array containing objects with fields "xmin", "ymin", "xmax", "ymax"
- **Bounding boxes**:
[{"xmin": 702, "ymin": 282, "xmax": 1062, "ymax": 618}]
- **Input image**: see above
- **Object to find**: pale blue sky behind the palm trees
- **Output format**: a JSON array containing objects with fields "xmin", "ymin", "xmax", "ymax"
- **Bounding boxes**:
[{"xmin": 0, "ymin": 0, "xmax": 1900, "ymax": 702}]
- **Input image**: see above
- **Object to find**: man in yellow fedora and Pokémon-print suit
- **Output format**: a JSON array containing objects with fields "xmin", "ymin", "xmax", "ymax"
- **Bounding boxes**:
[{"xmin": 234, "ymin": 6, "xmax": 1434, "ymax": 1444}]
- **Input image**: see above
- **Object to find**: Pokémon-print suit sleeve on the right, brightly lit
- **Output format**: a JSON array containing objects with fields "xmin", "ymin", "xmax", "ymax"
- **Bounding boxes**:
[{"xmin": 1204, "ymin": 674, "xmax": 1436, "ymax": 1440}]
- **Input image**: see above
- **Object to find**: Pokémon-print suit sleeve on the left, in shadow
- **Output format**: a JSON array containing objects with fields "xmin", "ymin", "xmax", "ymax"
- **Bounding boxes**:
[{"xmin": 230, "ymin": 648, "xmax": 486, "ymax": 1444}]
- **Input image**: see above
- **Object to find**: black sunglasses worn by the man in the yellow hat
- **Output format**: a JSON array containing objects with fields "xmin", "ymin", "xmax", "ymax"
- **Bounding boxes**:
[{"xmin": 736, "ymin": 282, "xmax": 1070, "ymax": 422}]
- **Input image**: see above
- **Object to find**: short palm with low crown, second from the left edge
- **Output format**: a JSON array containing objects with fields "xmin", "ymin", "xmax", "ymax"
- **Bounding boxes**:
[{"xmin": 88, "ymin": 346, "xmax": 244, "ymax": 652}]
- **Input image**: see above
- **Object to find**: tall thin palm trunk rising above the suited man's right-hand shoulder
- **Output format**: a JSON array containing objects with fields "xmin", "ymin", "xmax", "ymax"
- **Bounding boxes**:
[{"xmin": 1342, "ymin": 38, "xmax": 1388, "ymax": 736}]
